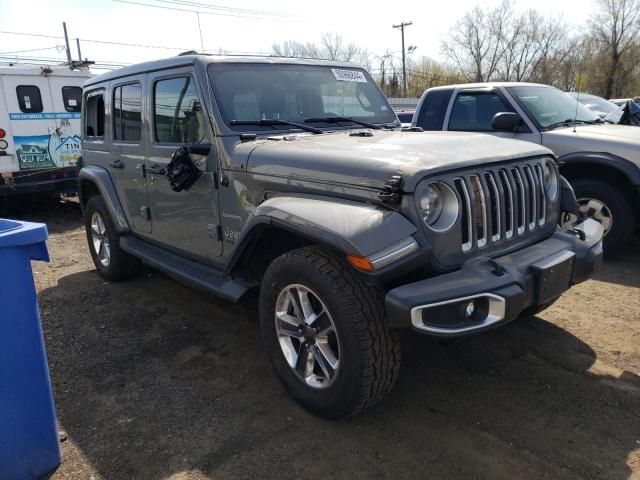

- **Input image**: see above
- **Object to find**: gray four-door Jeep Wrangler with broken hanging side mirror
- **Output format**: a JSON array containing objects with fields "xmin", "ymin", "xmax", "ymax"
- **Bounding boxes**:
[{"xmin": 79, "ymin": 55, "xmax": 603, "ymax": 418}]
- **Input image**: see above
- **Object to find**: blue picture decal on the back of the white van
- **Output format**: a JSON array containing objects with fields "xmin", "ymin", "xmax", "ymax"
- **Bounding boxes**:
[{"xmin": 13, "ymin": 133, "xmax": 80, "ymax": 170}]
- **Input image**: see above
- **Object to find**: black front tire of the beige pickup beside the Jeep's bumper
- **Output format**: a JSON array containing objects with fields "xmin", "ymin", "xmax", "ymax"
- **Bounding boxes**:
[{"xmin": 571, "ymin": 178, "xmax": 636, "ymax": 256}]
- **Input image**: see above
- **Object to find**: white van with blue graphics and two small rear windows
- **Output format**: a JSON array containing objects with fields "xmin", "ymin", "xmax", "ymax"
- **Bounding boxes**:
[{"xmin": 0, "ymin": 65, "xmax": 91, "ymax": 197}]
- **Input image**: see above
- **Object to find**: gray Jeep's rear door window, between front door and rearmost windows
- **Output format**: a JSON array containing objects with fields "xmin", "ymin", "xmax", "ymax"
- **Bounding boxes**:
[{"xmin": 113, "ymin": 83, "xmax": 142, "ymax": 142}]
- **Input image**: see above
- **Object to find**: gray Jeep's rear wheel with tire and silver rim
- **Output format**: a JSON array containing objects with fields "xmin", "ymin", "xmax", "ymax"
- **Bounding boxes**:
[{"xmin": 84, "ymin": 195, "xmax": 140, "ymax": 281}]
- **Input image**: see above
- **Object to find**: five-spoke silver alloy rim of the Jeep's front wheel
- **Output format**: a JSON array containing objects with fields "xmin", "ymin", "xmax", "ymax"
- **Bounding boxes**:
[{"xmin": 275, "ymin": 284, "xmax": 340, "ymax": 389}]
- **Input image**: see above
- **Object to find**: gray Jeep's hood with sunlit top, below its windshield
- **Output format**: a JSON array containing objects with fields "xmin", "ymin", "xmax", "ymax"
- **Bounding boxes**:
[{"xmin": 246, "ymin": 130, "xmax": 551, "ymax": 192}]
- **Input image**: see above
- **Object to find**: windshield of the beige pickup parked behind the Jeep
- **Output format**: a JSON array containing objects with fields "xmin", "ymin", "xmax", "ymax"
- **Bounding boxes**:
[{"xmin": 509, "ymin": 87, "xmax": 602, "ymax": 129}]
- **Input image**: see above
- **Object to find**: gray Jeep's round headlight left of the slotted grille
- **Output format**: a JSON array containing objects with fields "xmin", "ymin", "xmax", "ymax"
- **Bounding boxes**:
[{"xmin": 416, "ymin": 182, "xmax": 459, "ymax": 231}]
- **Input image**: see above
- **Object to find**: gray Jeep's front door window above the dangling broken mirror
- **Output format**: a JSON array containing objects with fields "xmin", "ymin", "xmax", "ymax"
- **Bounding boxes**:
[{"xmin": 153, "ymin": 77, "xmax": 205, "ymax": 143}]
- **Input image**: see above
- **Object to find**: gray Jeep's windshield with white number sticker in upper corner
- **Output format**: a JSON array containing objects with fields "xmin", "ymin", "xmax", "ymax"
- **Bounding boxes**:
[{"xmin": 208, "ymin": 63, "xmax": 396, "ymax": 131}]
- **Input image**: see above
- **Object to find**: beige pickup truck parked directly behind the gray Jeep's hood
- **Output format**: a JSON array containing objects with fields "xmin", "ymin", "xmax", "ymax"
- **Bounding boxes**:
[{"xmin": 412, "ymin": 82, "xmax": 640, "ymax": 254}]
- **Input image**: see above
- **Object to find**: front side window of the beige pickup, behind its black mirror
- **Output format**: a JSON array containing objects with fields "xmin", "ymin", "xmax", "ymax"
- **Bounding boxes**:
[{"xmin": 449, "ymin": 92, "xmax": 513, "ymax": 132}]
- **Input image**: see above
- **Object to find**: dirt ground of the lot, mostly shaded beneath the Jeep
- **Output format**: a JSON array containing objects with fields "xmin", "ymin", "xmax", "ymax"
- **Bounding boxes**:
[{"xmin": 0, "ymin": 197, "xmax": 640, "ymax": 480}]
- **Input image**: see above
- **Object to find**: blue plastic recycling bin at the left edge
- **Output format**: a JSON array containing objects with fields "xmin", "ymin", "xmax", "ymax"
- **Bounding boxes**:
[{"xmin": 0, "ymin": 219, "xmax": 60, "ymax": 480}]
